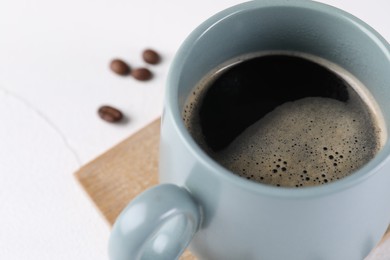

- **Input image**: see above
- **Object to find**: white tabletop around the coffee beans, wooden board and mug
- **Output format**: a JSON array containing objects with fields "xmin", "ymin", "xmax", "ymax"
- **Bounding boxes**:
[{"xmin": 0, "ymin": 0, "xmax": 390, "ymax": 260}]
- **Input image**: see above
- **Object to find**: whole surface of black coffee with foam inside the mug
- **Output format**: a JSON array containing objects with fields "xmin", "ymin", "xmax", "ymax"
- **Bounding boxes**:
[{"xmin": 183, "ymin": 52, "xmax": 384, "ymax": 187}]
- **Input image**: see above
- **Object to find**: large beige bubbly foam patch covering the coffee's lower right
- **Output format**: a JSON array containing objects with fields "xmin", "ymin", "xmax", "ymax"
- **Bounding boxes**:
[{"xmin": 212, "ymin": 95, "xmax": 380, "ymax": 187}]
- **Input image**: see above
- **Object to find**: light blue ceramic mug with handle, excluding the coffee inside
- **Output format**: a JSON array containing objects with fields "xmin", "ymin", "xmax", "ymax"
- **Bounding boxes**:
[{"xmin": 109, "ymin": 0, "xmax": 390, "ymax": 260}]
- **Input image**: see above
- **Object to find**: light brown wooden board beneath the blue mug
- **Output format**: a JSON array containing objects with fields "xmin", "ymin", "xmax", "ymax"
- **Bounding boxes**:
[{"xmin": 75, "ymin": 119, "xmax": 390, "ymax": 260}]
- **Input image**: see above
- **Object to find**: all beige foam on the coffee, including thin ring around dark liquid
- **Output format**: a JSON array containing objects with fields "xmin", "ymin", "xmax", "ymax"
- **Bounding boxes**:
[{"xmin": 182, "ymin": 51, "xmax": 387, "ymax": 187}]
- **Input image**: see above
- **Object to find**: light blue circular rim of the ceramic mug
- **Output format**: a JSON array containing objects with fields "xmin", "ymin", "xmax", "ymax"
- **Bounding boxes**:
[{"xmin": 163, "ymin": 0, "xmax": 390, "ymax": 199}]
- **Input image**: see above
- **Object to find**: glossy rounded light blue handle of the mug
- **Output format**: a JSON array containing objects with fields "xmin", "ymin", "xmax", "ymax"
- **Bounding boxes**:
[{"xmin": 108, "ymin": 184, "xmax": 201, "ymax": 260}]
